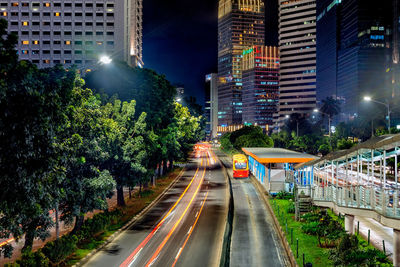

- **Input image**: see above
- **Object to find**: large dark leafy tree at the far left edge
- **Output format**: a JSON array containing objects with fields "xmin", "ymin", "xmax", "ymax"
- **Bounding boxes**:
[{"xmin": 0, "ymin": 61, "xmax": 75, "ymax": 251}]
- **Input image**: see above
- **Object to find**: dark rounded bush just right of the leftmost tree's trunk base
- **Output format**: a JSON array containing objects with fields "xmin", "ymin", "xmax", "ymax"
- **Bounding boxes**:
[{"xmin": 42, "ymin": 235, "xmax": 78, "ymax": 265}]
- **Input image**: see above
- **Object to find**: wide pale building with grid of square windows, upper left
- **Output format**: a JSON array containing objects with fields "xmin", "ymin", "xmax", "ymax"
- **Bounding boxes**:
[{"xmin": 0, "ymin": 0, "xmax": 143, "ymax": 70}]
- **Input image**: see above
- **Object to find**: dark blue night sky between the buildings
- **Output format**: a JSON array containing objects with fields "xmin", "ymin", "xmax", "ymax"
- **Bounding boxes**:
[{"xmin": 143, "ymin": 0, "xmax": 218, "ymax": 105}]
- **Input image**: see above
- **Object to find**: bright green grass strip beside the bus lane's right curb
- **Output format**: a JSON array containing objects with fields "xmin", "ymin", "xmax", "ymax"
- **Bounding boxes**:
[{"xmin": 270, "ymin": 199, "xmax": 332, "ymax": 267}]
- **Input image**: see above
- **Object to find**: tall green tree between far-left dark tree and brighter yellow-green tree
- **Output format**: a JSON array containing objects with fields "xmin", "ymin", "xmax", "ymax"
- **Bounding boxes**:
[{"xmin": 57, "ymin": 82, "xmax": 115, "ymax": 232}]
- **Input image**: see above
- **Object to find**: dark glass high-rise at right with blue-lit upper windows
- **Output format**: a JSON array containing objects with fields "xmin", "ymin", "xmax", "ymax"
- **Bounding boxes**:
[{"xmin": 337, "ymin": 0, "xmax": 392, "ymax": 119}]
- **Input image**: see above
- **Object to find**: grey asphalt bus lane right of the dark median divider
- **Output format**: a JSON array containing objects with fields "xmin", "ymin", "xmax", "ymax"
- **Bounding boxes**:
[{"xmin": 218, "ymin": 154, "xmax": 290, "ymax": 267}]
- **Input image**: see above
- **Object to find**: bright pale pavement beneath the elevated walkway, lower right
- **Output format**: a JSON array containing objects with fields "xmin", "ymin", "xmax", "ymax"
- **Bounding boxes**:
[{"xmin": 354, "ymin": 216, "xmax": 393, "ymax": 260}]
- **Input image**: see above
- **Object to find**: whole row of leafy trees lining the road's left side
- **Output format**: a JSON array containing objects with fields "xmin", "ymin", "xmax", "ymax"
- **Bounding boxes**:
[{"xmin": 0, "ymin": 20, "xmax": 202, "ymax": 256}]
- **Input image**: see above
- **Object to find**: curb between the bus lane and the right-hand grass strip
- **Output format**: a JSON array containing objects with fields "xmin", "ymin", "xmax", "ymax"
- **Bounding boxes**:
[{"xmin": 250, "ymin": 175, "xmax": 299, "ymax": 267}]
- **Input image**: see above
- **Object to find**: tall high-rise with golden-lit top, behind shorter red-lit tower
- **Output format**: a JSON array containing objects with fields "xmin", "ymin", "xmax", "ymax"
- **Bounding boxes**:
[{"xmin": 218, "ymin": 0, "xmax": 265, "ymax": 128}]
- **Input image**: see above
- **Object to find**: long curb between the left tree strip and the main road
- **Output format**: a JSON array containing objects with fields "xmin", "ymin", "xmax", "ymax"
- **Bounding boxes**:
[{"xmin": 72, "ymin": 167, "xmax": 185, "ymax": 267}]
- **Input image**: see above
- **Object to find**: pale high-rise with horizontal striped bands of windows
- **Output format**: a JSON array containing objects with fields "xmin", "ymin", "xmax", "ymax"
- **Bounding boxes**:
[{"xmin": 278, "ymin": 0, "xmax": 316, "ymax": 123}]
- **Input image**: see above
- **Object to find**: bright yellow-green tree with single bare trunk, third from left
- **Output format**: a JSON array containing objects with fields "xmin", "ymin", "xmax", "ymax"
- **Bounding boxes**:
[{"xmin": 99, "ymin": 100, "xmax": 147, "ymax": 206}]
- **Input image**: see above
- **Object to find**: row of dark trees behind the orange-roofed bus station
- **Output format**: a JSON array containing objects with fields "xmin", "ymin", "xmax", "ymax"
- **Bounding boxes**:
[{"xmin": 271, "ymin": 97, "xmax": 399, "ymax": 155}]
